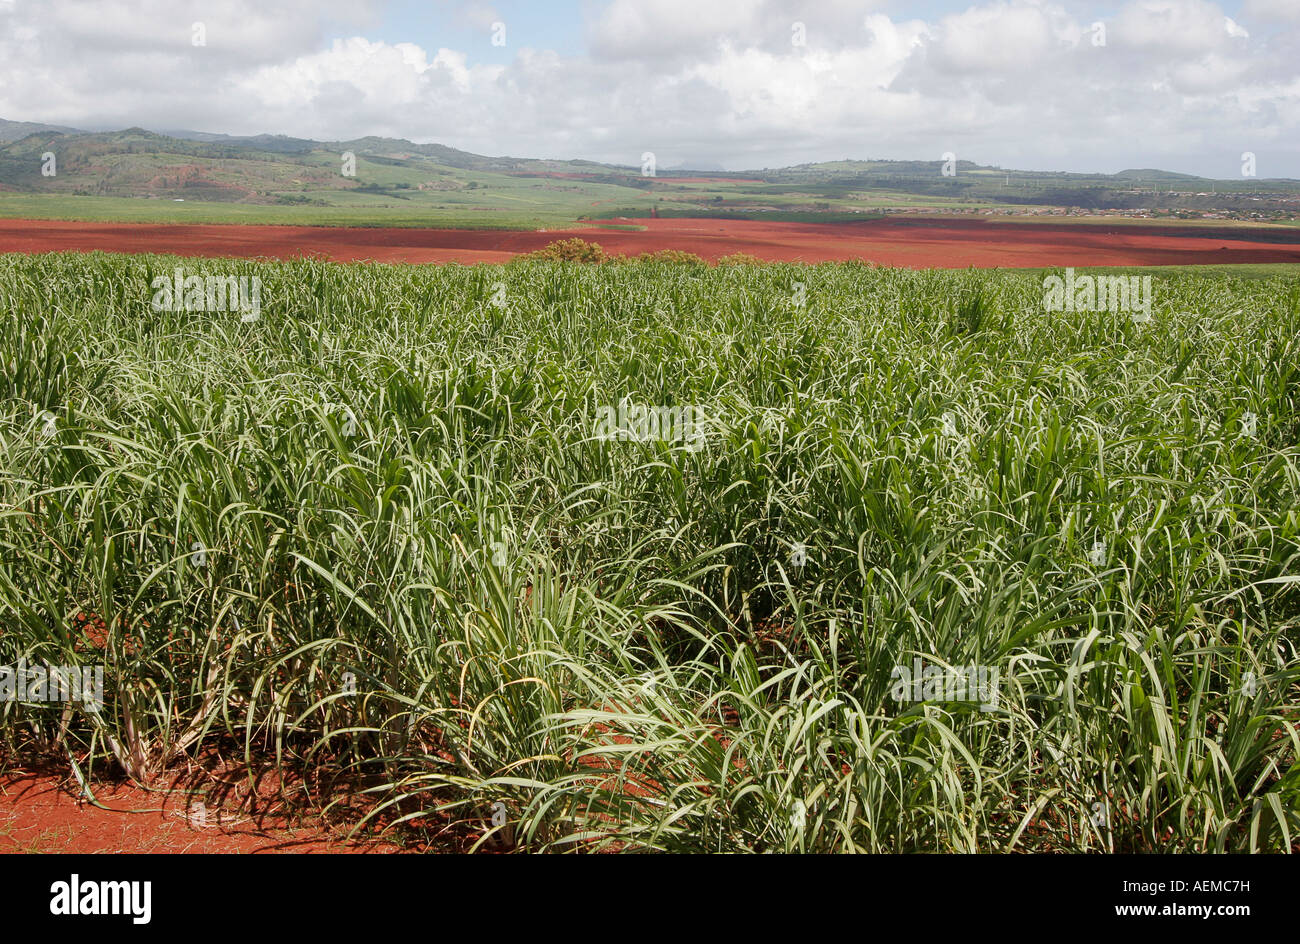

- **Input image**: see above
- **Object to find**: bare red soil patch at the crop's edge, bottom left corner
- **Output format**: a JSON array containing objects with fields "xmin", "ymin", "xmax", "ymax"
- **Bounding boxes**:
[{"xmin": 0, "ymin": 772, "xmax": 400, "ymax": 853}]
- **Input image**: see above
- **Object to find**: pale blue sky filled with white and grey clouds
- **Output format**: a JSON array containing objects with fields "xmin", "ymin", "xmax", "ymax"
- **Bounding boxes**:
[{"xmin": 0, "ymin": 0, "xmax": 1300, "ymax": 178}]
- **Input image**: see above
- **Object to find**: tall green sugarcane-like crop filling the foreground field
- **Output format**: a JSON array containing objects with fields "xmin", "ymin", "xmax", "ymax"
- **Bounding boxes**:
[{"xmin": 0, "ymin": 254, "xmax": 1300, "ymax": 852}]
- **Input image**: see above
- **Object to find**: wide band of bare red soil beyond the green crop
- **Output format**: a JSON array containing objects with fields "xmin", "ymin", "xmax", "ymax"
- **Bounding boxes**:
[{"xmin": 0, "ymin": 217, "xmax": 1300, "ymax": 268}]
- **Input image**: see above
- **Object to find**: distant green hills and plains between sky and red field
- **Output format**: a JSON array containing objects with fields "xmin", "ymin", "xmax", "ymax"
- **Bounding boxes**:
[{"xmin": 0, "ymin": 120, "xmax": 1300, "ymax": 225}]
